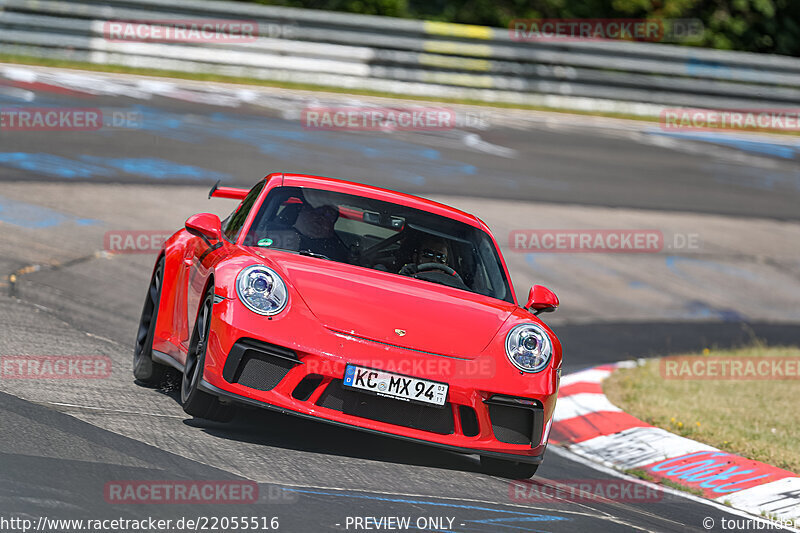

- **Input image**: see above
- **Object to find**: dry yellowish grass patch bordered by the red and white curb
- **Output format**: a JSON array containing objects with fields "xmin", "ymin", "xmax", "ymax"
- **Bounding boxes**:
[{"xmin": 603, "ymin": 345, "xmax": 800, "ymax": 472}]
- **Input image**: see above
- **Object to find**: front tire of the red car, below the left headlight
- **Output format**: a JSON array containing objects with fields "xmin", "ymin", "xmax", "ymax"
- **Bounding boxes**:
[{"xmin": 181, "ymin": 285, "xmax": 235, "ymax": 422}]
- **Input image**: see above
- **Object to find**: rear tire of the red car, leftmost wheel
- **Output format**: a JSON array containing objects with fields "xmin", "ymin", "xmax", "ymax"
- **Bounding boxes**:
[{"xmin": 133, "ymin": 257, "xmax": 168, "ymax": 387}]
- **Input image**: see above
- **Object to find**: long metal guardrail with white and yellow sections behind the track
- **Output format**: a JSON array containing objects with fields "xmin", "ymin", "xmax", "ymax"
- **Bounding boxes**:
[{"xmin": 0, "ymin": 0, "xmax": 800, "ymax": 114}]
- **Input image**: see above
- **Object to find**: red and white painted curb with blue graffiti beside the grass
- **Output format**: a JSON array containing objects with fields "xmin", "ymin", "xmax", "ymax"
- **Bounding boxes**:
[{"xmin": 550, "ymin": 361, "xmax": 800, "ymax": 524}]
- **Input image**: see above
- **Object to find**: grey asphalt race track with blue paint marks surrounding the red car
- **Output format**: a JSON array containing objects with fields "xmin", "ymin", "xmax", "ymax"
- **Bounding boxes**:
[{"xmin": 0, "ymin": 66, "xmax": 800, "ymax": 532}]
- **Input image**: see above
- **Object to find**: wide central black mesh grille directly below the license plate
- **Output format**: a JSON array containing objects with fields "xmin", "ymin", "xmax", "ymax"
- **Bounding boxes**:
[{"xmin": 317, "ymin": 379, "xmax": 454, "ymax": 435}]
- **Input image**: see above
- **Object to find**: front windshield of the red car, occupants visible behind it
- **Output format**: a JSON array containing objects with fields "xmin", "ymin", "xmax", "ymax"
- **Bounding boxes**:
[{"xmin": 243, "ymin": 187, "xmax": 513, "ymax": 302}]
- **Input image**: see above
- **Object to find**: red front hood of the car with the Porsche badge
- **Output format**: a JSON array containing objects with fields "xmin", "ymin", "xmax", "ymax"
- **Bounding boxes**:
[{"xmin": 263, "ymin": 251, "xmax": 516, "ymax": 359}]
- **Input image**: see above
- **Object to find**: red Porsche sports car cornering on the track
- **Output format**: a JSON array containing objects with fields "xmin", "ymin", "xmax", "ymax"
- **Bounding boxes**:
[{"xmin": 134, "ymin": 173, "xmax": 561, "ymax": 478}]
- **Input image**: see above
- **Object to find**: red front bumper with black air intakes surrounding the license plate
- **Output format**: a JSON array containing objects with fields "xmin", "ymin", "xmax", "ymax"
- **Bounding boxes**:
[{"xmin": 201, "ymin": 299, "xmax": 557, "ymax": 464}]
